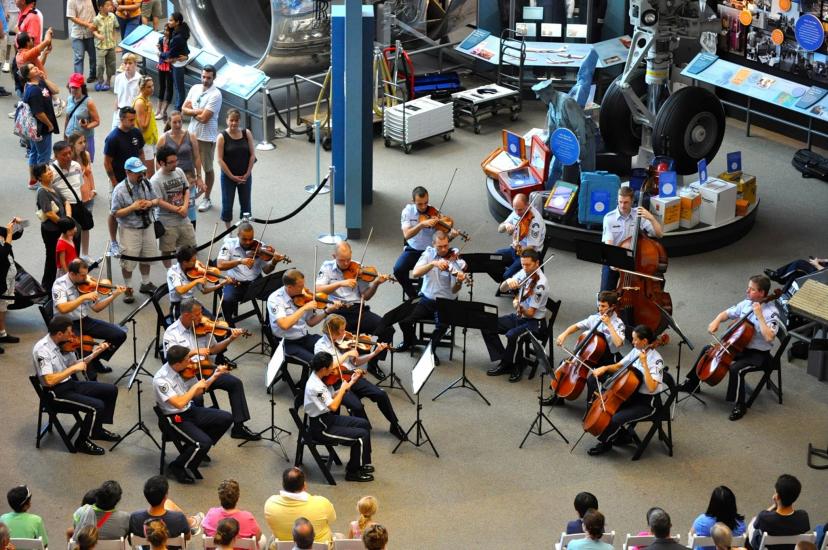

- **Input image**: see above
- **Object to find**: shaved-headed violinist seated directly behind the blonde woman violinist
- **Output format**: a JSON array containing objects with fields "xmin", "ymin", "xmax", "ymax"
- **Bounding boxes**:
[{"xmin": 316, "ymin": 241, "xmax": 394, "ymax": 380}]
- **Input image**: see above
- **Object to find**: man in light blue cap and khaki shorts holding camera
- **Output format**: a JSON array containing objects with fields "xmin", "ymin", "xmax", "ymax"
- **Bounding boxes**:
[{"xmin": 112, "ymin": 157, "xmax": 160, "ymax": 304}]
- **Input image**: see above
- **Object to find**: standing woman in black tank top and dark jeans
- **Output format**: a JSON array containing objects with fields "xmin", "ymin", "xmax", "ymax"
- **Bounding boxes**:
[{"xmin": 216, "ymin": 109, "xmax": 256, "ymax": 229}]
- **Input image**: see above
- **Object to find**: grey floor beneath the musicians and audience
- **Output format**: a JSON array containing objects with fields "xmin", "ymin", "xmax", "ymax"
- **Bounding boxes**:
[{"xmin": 0, "ymin": 42, "xmax": 828, "ymax": 549}]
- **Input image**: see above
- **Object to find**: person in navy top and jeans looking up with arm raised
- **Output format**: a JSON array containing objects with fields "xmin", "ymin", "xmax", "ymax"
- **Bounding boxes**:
[{"xmin": 20, "ymin": 63, "xmax": 60, "ymax": 190}]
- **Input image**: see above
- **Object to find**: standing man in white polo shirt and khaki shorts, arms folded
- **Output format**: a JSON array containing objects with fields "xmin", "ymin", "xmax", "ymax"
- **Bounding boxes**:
[{"xmin": 180, "ymin": 65, "xmax": 222, "ymax": 212}]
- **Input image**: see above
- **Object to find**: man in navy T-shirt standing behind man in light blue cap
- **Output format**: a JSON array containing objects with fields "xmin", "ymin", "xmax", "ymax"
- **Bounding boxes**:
[{"xmin": 104, "ymin": 106, "xmax": 144, "ymax": 256}]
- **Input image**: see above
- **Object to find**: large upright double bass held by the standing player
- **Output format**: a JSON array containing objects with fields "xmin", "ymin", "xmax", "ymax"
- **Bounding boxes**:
[{"xmin": 616, "ymin": 183, "xmax": 673, "ymax": 335}]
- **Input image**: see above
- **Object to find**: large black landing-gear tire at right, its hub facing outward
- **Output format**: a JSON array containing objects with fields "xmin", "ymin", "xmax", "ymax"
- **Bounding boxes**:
[{"xmin": 653, "ymin": 87, "xmax": 725, "ymax": 174}]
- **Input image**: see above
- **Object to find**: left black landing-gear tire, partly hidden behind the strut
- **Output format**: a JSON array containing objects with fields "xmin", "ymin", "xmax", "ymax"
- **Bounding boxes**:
[{"xmin": 598, "ymin": 69, "xmax": 647, "ymax": 156}]
